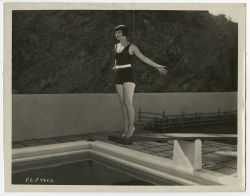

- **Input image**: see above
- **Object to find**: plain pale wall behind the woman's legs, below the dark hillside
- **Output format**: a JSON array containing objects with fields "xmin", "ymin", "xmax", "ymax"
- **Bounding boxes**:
[{"xmin": 12, "ymin": 92, "xmax": 237, "ymax": 141}]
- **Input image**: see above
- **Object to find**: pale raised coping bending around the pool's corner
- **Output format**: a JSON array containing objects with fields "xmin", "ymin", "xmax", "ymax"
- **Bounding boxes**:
[{"xmin": 12, "ymin": 141, "xmax": 237, "ymax": 186}]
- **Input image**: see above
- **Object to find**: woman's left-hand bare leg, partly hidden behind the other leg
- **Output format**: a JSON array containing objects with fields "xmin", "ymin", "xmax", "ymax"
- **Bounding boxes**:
[{"xmin": 116, "ymin": 84, "xmax": 129, "ymax": 136}]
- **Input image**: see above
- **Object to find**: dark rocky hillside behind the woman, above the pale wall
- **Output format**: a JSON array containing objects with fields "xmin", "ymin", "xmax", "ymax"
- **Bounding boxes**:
[{"xmin": 12, "ymin": 10, "xmax": 238, "ymax": 94}]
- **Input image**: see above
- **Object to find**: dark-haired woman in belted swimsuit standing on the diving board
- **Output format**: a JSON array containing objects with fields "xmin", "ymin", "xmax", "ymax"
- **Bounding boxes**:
[{"xmin": 112, "ymin": 25, "xmax": 167, "ymax": 138}]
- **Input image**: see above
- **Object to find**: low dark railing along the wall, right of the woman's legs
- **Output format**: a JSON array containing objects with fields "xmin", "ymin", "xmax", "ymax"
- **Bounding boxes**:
[{"xmin": 138, "ymin": 109, "xmax": 237, "ymax": 132}]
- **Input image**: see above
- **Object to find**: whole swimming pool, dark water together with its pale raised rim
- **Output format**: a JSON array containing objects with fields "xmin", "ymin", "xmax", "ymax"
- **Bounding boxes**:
[{"xmin": 12, "ymin": 141, "xmax": 234, "ymax": 186}]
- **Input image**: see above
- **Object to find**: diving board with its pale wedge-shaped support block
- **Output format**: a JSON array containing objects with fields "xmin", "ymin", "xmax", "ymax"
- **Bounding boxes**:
[{"xmin": 108, "ymin": 132, "xmax": 237, "ymax": 172}]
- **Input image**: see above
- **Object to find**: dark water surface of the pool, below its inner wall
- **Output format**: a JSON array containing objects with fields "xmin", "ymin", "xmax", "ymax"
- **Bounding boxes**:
[{"xmin": 12, "ymin": 160, "xmax": 153, "ymax": 185}]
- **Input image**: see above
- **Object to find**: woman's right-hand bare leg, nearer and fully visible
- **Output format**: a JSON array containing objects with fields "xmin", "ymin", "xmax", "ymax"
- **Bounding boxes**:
[{"xmin": 123, "ymin": 82, "xmax": 135, "ymax": 137}]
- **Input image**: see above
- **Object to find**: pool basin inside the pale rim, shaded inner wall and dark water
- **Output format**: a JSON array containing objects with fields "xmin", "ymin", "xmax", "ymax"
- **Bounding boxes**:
[{"xmin": 12, "ymin": 142, "xmax": 179, "ymax": 186}]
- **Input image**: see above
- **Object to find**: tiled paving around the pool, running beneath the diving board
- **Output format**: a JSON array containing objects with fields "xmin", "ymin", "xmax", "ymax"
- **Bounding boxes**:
[{"xmin": 12, "ymin": 132, "xmax": 237, "ymax": 177}]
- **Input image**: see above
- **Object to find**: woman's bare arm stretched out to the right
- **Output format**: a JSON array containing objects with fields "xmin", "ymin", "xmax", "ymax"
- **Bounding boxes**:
[{"xmin": 131, "ymin": 44, "xmax": 167, "ymax": 74}]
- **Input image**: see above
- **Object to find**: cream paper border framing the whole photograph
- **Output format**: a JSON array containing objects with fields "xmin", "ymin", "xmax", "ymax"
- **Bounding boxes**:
[{"xmin": 3, "ymin": 3, "xmax": 246, "ymax": 192}]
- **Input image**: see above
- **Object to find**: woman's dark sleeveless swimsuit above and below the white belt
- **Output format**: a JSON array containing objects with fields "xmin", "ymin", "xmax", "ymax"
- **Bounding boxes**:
[{"xmin": 115, "ymin": 44, "xmax": 135, "ymax": 84}]
